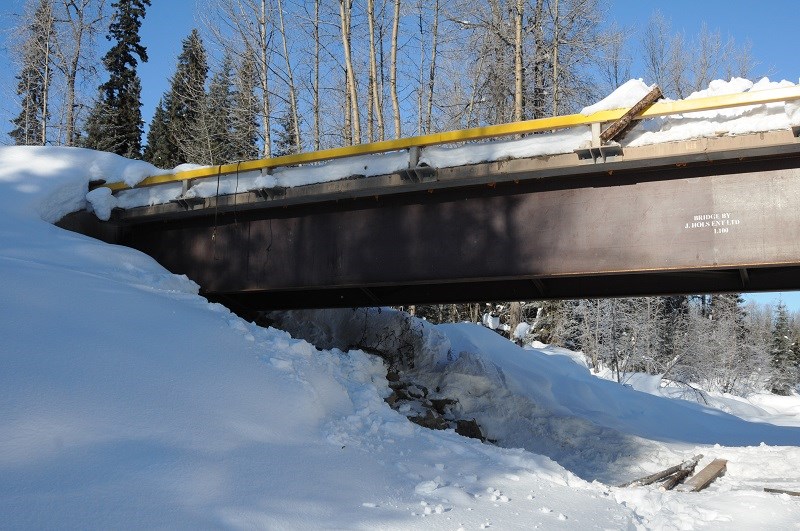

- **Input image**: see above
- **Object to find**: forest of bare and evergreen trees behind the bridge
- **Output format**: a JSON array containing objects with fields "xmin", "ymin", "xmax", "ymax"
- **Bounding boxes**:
[{"xmin": 4, "ymin": 0, "xmax": 800, "ymax": 395}]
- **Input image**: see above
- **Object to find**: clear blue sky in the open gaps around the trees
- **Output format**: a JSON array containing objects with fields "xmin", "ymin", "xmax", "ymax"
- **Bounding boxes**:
[{"xmin": 0, "ymin": 0, "xmax": 800, "ymax": 310}]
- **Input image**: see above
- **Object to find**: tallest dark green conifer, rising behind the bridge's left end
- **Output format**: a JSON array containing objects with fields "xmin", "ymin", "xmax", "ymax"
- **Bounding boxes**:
[{"xmin": 85, "ymin": 0, "xmax": 150, "ymax": 158}]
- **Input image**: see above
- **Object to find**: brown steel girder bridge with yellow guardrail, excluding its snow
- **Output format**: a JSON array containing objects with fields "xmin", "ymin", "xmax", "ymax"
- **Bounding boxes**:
[{"xmin": 61, "ymin": 87, "xmax": 800, "ymax": 311}]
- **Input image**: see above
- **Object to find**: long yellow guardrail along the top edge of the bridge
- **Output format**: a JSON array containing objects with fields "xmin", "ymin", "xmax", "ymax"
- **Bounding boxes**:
[{"xmin": 104, "ymin": 85, "xmax": 800, "ymax": 191}]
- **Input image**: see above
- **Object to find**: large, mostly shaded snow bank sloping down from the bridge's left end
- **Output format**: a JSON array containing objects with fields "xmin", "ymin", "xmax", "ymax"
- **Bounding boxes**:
[{"xmin": 0, "ymin": 144, "xmax": 634, "ymax": 529}]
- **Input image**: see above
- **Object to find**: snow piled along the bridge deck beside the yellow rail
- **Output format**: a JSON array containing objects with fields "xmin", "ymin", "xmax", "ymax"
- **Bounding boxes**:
[{"xmin": 89, "ymin": 78, "xmax": 800, "ymax": 219}]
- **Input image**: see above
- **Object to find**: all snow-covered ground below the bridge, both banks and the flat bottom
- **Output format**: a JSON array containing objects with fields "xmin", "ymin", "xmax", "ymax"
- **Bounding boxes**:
[{"xmin": 0, "ymin": 143, "xmax": 800, "ymax": 529}]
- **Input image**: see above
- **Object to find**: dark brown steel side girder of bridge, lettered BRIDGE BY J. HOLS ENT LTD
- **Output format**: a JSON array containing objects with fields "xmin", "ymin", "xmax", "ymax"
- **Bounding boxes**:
[{"xmin": 59, "ymin": 133, "xmax": 800, "ymax": 310}]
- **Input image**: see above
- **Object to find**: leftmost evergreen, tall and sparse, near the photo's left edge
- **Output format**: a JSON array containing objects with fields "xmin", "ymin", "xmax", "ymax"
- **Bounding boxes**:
[{"xmin": 10, "ymin": 0, "xmax": 55, "ymax": 146}]
